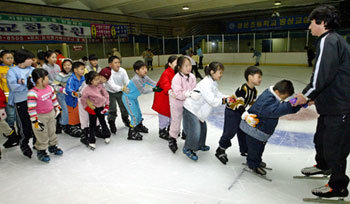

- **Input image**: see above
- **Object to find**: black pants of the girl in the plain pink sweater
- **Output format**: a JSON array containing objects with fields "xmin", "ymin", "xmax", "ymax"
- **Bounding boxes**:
[{"xmin": 88, "ymin": 107, "xmax": 111, "ymax": 144}]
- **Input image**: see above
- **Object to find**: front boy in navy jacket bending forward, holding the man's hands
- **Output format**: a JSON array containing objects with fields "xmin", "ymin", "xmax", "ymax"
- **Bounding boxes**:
[{"xmin": 239, "ymin": 80, "xmax": 300, "ymax": 175}]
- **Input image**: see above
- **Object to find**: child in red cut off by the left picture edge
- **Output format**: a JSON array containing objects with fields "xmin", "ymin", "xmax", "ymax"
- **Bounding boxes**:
[{"xmin": 0, "ymin": 88, "xmax": 19, "ymax": 150}]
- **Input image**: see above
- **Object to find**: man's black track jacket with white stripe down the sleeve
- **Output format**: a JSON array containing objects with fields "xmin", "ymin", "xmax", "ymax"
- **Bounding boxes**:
[{"xmin": 303, "ymin": 31, "xmax": 350, "ymax": 115}]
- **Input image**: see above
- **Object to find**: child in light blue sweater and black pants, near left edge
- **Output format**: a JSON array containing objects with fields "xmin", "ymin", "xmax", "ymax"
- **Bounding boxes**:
[{"xmin": 7, "ymin": 49, "xmax": 34, "ymax": 158}]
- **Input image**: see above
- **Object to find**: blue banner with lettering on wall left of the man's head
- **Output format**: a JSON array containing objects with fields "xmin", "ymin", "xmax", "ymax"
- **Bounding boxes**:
[{"xmin": 226, "ymin": 15, "xmax": 310, "ymax": 33}]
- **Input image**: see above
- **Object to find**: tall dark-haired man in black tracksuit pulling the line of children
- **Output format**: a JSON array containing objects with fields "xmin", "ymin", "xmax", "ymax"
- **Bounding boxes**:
[{"xmin": 296, "ymin": 5, "xmax": 350, "ymax": 198}]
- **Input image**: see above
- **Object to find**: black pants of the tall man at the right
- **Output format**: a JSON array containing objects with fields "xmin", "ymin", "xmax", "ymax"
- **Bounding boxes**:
[{"xmin": 314, "ymin": 114, "xmax": 350, "ymax": 190}]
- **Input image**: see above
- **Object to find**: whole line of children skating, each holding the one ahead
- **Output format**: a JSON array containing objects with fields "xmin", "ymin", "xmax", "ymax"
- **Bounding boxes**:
[{"xmin": 0, "ymin": 50, "xmax": 306, "ymax": 175}]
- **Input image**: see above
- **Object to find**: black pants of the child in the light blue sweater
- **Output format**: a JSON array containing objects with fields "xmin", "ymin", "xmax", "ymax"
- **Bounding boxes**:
[{"xmin": 15, "ymin": 101, "xmax": 35, "ymax": 147}]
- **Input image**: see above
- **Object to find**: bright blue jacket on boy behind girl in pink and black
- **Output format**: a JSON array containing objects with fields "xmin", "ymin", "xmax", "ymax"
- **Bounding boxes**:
[{"xmin": 66, "ymin": 74, "xmax": 85, "ymax": 108}]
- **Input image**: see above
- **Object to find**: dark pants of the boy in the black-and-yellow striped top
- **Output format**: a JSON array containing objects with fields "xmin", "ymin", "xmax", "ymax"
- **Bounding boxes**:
[{"xmin": 219, "ymin": 108, "xmax": 248, "ymax": 153}]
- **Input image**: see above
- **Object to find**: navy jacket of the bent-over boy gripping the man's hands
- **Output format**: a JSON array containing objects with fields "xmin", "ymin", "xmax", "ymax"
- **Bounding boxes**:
[{"xmin": 240, "ymin": 86, "xmax": 300, "ymax": 142}]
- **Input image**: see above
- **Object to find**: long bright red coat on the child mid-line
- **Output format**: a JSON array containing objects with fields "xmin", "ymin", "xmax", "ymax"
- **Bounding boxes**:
[{"xmin": 152, "ymin": 67, "xmax": 175, "ymax": 117}]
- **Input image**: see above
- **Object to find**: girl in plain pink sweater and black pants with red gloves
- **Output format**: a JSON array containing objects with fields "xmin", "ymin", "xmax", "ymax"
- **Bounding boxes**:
[{"xmin": 81, "ymin": 71, "xmax": 111, "ymax": 149}]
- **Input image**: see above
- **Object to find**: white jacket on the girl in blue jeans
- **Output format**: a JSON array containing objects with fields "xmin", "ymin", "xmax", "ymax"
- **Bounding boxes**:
[{"xmin": 184, "ymin": 76, "xmax": 223, "ymax": 122}]
